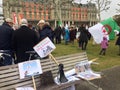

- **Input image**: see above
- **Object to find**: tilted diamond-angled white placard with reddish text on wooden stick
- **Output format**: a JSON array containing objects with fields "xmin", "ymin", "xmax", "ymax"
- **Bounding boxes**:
[{"xmin": 33, "ymin": 37, "xmax": 56, "ymax": 58}]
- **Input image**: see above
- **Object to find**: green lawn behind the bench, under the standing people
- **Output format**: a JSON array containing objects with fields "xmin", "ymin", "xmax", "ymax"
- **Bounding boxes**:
[{"xmin": 52, "ymin": 40, "xmax": 120, "ymax": 71}]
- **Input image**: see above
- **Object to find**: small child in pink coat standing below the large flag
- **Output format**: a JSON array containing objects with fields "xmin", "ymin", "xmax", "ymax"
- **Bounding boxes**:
[{"xmin": 99, "ymin": 37, "xmax": 108, "ymax": 55}]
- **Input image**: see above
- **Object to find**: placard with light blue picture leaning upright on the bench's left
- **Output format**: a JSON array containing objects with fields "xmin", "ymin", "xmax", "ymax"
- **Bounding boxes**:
[{"xmin": 18, "ymin": 60, "xmax": 42, "ymax": 79}]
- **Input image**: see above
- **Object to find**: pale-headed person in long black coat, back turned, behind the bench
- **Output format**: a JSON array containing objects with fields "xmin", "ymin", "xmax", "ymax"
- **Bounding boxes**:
[{"xmin": 12, "ymin": 19, "xmax": 38, "ymax": 63}]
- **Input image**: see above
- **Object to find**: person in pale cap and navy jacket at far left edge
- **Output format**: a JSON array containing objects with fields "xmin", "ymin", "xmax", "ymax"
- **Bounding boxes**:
[{"xmin": 0, "ymin": 18, "xmax": 14, "ymax": 66}]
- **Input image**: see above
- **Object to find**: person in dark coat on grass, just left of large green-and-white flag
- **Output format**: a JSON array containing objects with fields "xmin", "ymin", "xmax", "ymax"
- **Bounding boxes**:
[{"xmin": 79, "ymin": 24, "xmax": 88, "ymax": 50}]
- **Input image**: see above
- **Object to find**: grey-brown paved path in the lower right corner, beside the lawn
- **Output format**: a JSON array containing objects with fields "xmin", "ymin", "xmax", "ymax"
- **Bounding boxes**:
[{"xmin": 76, "ymin": 66, "xmax": 120, "ymax": 90}]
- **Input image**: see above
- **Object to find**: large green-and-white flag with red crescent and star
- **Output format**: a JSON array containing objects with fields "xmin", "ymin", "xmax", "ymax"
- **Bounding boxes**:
[{"xmin": 88, "ymin": 17, "xmax": 120, "ymax": 44}]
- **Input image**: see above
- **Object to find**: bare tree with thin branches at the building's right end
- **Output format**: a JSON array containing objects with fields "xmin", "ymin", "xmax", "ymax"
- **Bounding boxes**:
[{"xmin": 88, "ymin": 0, "xmax": 111, "ymax": 21}]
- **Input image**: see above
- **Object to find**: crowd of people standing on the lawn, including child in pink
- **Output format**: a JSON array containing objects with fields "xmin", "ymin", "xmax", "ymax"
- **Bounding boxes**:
[{"xmin": 0, "ymin": 18, "xmax": 120, "ymax": 66}]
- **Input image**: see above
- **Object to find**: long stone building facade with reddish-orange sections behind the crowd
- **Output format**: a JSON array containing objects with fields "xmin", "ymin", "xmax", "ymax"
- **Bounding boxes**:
[{"xmin": 3, "ymin": 0, "xmax": 98, "ymax": 27}]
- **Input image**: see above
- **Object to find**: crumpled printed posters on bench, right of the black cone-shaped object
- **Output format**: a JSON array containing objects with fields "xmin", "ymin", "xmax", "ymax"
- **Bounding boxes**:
[{"xmin": 75, "ymin": 60, "xmax": 101, "ymax": 80}]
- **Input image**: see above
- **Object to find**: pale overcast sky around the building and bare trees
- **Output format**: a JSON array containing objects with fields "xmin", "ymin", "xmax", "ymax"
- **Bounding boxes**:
[{"xmin": 0, "ymin": 0, "xmax": 120, "ymax": 19}]
